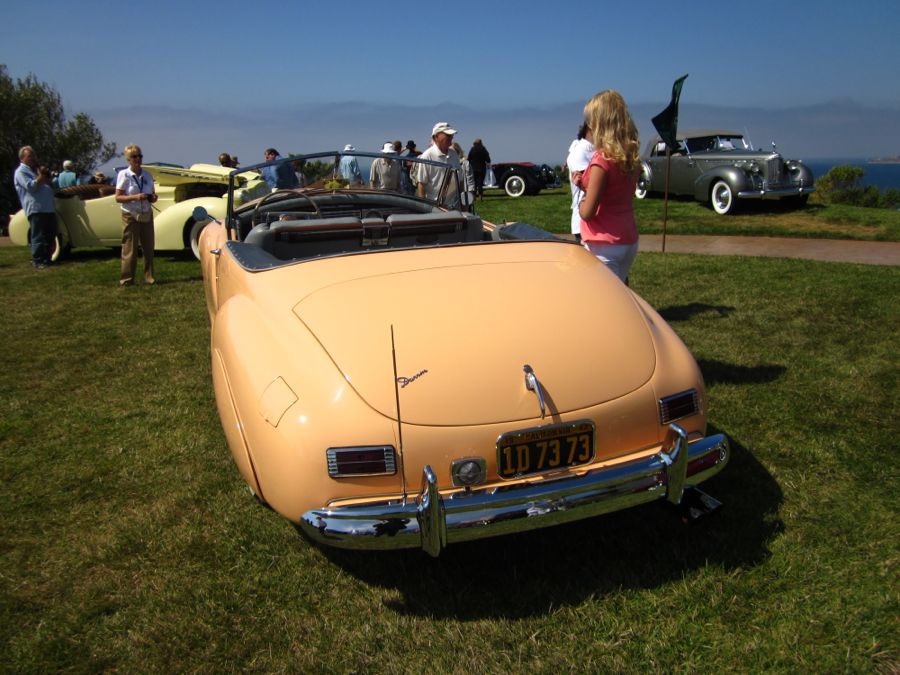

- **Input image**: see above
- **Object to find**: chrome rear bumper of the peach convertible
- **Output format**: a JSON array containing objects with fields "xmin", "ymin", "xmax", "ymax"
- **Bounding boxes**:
[{"xmin": 299, "ymin": 424, "xmax": 730, "ymax": 556}]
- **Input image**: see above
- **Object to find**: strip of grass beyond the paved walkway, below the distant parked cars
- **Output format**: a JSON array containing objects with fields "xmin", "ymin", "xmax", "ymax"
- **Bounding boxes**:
[{"xmin": 476, "ymin": 186, "xmax": 900, "ymax": 241}]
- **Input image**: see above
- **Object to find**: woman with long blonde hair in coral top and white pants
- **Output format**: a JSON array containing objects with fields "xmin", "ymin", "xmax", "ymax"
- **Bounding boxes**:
[{"xmin": 578, "ymin": 89, "xmax": 641, "ymax": 283}]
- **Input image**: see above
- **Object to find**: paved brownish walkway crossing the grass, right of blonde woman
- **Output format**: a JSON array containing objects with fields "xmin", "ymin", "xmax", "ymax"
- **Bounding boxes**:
[{"xmin": 0, "ymin": 234, "xmax": 900, "ymax": 265}]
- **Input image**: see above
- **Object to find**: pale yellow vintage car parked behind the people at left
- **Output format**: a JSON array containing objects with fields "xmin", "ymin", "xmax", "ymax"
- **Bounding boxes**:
[{"xmin": 9, "ymin": 164, "xmax": 269, "ymax": 260}]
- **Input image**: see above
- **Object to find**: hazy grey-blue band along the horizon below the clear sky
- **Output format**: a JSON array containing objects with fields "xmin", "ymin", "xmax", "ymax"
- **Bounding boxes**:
[{"xmin": 88, "ymin": 99, "xmax": 900, "ymax": 172}]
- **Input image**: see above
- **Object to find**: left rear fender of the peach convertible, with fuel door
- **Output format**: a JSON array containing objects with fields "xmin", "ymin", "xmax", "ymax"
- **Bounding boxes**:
[{"xmin": 210, "ymin": 292, "xmax": 400, "ymax": 521}]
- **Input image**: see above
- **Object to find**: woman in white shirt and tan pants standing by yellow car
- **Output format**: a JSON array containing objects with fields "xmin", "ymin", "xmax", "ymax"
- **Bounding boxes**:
[{"xmin": 116, "ymin": 145, "xmax": 157, "ymax": 286}]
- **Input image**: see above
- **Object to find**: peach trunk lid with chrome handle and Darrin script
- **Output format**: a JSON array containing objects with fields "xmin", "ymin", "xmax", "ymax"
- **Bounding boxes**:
[{"xmin": 293, "ymin": 243, "xmax": 656, "ymax": 426}]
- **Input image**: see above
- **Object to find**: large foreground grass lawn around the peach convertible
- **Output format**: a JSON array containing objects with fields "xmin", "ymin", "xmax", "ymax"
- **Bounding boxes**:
[{"xmin": 0, "ymin": 238, "xmax": 900, "ymax": 673}]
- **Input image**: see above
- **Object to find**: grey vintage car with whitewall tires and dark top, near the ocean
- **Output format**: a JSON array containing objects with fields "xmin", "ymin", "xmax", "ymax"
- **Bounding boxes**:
[{"xmin": 635, "ymin": 129, "xmax": 815, "ymax": 215}]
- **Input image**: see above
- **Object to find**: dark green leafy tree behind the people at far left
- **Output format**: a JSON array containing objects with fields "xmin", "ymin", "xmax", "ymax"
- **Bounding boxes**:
[{"xmin": 0, "ymin": 64, "xmax": 116, "ymax": 215}]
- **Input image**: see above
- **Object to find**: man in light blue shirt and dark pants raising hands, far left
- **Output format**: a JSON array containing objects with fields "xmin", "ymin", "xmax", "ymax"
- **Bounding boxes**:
[{"xmin": 13, "ymin": 145, "xmax": 56, "ymax": 270}]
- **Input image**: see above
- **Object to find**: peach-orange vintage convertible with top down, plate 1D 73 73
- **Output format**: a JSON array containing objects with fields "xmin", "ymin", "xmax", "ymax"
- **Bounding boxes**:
[{"xmin": 195, "ymin": 152, "xmax": 729, "ymax": 555}]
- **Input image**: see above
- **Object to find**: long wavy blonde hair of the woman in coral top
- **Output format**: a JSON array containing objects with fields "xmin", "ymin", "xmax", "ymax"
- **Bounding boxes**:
[{"xmin": 584, "ymin": 89, "xmax": 641, "ymax": 175}]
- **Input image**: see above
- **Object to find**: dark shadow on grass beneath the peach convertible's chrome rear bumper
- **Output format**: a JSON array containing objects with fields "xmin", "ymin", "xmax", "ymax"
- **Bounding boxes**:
[{"xmin": 322, "ymin": 429, "xmax": 783, "ymax": 620}]
